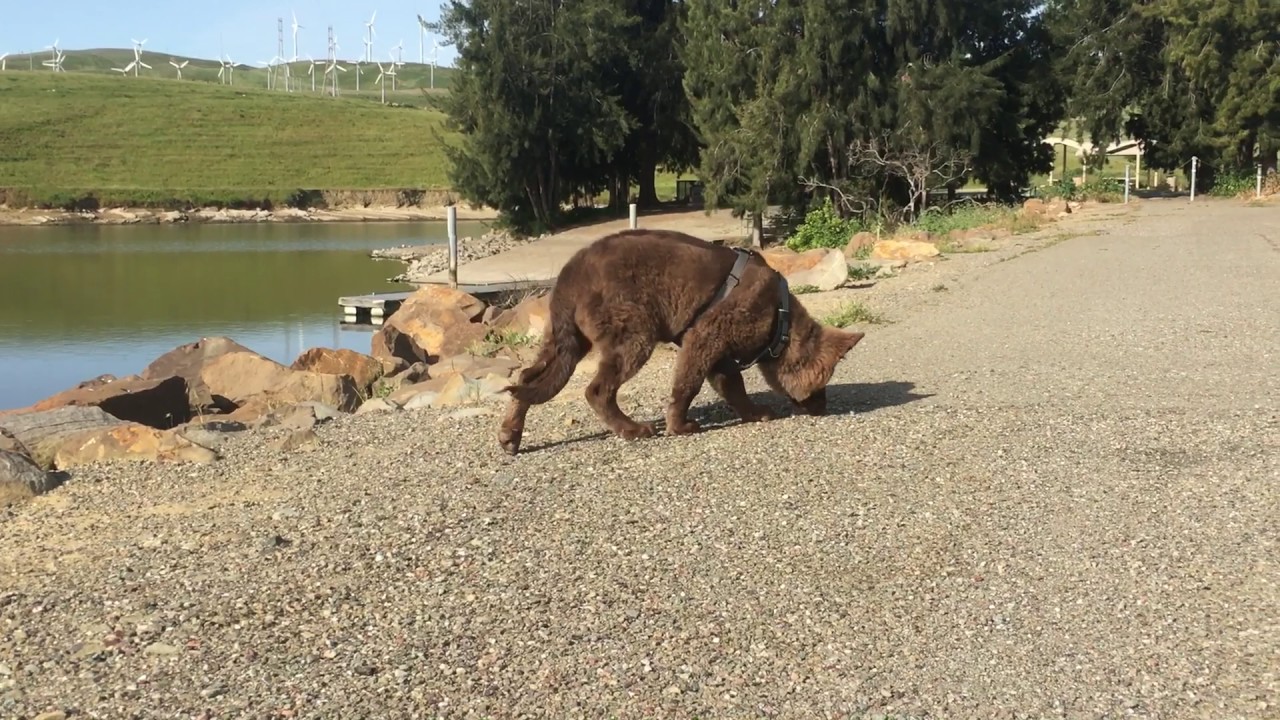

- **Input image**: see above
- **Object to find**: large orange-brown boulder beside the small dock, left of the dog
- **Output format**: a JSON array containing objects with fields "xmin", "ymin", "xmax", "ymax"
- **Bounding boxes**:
[{"xmin": 371, "ymin": 286, "xmax": 489, "ymax": 364}]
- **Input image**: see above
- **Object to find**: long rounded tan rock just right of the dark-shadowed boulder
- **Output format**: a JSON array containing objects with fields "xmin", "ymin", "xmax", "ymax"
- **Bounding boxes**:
[{"xmin": 201, "ymin": 352, "xmax": 361, "ymax": 412}]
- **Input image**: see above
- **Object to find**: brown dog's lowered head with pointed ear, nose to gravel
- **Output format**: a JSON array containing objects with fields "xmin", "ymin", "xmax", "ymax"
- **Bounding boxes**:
[{"xmin": 760, "ymin": 314, "xmax": 865, "ymax": 415}]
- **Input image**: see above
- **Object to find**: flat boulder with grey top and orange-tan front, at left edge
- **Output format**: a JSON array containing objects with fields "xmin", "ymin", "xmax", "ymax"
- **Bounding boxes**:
[{"xmin": 0, "ymin": 405, "xmax": 216, "ymax": 470}]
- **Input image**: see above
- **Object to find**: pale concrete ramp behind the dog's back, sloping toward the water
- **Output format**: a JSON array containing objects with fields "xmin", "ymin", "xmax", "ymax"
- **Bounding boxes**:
[{"xmin": 417, "ymin": 204, "xmax": 746, "ymax": 287}]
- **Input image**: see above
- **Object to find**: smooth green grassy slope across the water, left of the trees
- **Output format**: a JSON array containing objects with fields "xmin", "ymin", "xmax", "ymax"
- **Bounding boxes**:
[{"xmin": 0, "ymin": 70, "xmax": 460, "ymax": 206}]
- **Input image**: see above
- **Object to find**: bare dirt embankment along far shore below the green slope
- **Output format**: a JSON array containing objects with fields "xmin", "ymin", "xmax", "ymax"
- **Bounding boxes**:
[{"xmin": 0, "ymin": 188, "xmax": 497, "ymax": 225}]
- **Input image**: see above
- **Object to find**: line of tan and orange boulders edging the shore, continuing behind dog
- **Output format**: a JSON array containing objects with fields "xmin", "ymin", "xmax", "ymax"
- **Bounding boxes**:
[{"xmin": 0, "ymin": 193, "xmax": 1100, "ymax": 505}]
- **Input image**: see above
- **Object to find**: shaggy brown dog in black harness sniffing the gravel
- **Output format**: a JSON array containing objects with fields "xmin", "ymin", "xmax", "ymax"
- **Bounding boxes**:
[{"xmin": 498, "ymin": 229, "xmax": 863, "ymax": 455}]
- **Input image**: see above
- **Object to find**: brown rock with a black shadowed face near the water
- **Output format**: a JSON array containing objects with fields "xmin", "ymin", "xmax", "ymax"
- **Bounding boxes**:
[{"xmin": 29, "ymin": 375, "xmax": 191, "ymax": 428}]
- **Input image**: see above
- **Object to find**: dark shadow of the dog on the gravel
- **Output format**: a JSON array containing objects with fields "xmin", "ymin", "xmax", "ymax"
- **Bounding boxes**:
[{"xmin": 521, "ymin": 380, "xmax": 933, "ymax": 454}]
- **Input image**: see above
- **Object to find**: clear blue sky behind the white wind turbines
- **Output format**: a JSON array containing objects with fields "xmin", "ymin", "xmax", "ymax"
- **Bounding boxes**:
[{"xmin": 0, "ymin": 0, "xmax": 456, "ymax": 65}]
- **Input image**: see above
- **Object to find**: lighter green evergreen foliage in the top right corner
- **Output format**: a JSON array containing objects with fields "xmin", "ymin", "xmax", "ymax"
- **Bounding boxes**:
[{"xmin": 1048, "ymin": 0, "xmax": 1280, "ymax": 183}]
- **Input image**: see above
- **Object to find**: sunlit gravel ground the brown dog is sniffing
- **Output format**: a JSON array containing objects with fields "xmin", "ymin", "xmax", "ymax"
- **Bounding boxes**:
[{"xmin": 0, "ymin": 196, "xmax": 1280, "ymax": 719}]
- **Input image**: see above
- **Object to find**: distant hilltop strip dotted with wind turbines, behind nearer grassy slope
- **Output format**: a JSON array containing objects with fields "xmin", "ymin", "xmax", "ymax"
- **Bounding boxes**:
[{"xmin": 5, "ymin": 47, "xmax": 454, "ymax": 105}]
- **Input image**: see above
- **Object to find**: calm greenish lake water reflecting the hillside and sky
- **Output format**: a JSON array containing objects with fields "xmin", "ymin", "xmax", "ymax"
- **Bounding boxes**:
[{"xmin": 0, "ymin": 222, "xmax": 484, "ymax": 409}]
